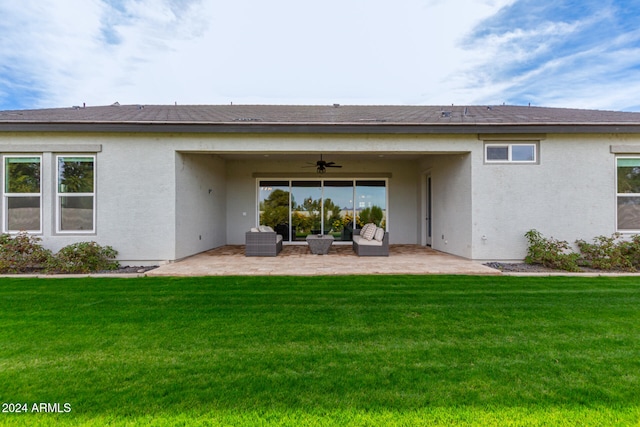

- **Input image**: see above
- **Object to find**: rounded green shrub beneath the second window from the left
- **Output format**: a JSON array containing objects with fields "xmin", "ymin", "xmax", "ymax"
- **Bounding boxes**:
[{"xmin": 49, "ymin": 242, "xmax": 120, "ymax": 273}]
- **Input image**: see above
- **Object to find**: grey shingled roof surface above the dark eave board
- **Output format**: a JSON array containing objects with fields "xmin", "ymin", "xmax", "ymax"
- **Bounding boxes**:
[{"xmin": 0, "ymin": 104, "xmax": 640, "ymax": 124}]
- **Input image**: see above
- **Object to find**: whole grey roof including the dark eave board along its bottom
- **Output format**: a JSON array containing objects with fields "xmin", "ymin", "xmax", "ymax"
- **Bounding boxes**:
[{"xmin": 0, "ymin": 103, "xmax": 640, "ymax": 133}]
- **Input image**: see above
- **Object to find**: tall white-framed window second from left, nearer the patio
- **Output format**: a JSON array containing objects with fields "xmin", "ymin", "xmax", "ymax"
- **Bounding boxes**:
[{"xmin": 56, "ymin": 156, "xmax": 95, "ymax": 233}]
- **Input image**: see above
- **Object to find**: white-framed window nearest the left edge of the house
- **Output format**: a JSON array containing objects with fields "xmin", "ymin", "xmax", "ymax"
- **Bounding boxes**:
[{"xmin": 3, "ymin": 156, "xmax": 42, "ymax": 232}]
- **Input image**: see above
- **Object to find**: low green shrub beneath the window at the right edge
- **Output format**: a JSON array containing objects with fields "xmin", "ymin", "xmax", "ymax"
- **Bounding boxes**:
[{"xmin": 576, "ymin": 233, "xmax": 640, "ymax": 271}]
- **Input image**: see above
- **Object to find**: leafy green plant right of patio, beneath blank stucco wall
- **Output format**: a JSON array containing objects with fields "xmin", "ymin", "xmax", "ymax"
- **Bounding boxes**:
[{"xmin": 525, "ymin": 230, "xmax": 580, "ymax": 271}]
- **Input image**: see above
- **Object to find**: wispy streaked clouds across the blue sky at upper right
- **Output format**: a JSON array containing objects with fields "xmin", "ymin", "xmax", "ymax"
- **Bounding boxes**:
[{"xmin": 465, "ymin": 0, "xmax": 640, "ymax": 110}]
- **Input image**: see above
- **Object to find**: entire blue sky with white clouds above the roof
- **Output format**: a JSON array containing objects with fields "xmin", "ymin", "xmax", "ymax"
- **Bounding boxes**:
[{"xmin": 0, "ymin": 0, "xmax": 640, "ymax": 111}]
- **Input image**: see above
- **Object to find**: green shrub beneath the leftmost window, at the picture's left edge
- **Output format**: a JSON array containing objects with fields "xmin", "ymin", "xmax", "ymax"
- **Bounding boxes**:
[{"xmin": 0, "ymin": 232, "xmax": 52, "ymax": 274}]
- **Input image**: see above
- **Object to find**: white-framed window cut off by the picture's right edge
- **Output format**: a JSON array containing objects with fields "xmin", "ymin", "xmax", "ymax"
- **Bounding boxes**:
[{"xmin": 617, "ymin": 158, "xmax": 640, "ymax": 231}]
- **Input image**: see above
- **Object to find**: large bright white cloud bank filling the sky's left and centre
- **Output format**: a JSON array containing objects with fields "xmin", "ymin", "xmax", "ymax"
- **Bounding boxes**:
[{"xmin": 0, "ymin": 0, "xmax": 509, "ymax": 108}]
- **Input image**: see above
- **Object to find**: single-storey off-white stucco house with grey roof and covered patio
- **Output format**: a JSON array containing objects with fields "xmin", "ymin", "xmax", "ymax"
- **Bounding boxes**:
[{"xmin": 0, "ymin": 103, "xmax": 640, "ymax": 265}]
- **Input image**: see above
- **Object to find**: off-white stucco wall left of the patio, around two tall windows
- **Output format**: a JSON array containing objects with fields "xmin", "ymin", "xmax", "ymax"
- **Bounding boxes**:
[{"xmin": 0, "ymin": 133, "xmax": 175, "ymax": 265}]
